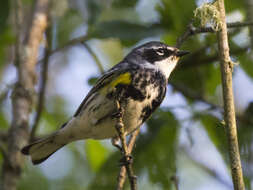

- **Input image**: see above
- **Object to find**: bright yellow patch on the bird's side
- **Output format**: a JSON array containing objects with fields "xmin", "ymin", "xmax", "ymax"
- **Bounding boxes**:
[{"xmin": 101, "ymin": 73, "xmax": 131, "ymax": 95}]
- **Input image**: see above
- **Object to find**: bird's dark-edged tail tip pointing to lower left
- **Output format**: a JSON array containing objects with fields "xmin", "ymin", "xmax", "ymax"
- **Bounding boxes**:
[{"xmin": 21, "ymin": 132, "xmax": 65, "ymax": 164}]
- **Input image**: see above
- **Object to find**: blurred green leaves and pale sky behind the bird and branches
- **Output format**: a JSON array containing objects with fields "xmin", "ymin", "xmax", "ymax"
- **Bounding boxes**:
[{"xmin": 0, "ymin": 0, "xmax": 253, "ymax": 190}]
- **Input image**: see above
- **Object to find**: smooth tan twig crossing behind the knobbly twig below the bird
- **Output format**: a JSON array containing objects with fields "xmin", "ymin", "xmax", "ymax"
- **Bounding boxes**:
[{"xmin": 116, "ymin": 128, "xmax": 140, "ymax": 190}]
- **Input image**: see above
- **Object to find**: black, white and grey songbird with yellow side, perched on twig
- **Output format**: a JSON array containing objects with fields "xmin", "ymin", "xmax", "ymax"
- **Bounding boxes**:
[{"xmin": 21, "ymin": 41, "xmax": 189, "ymax": 164}]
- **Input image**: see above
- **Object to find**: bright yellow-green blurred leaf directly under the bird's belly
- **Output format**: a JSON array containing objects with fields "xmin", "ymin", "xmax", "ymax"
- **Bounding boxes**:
[{"xmin": 85, "ymin": 140, "xmax": 108, "ymax": 172}]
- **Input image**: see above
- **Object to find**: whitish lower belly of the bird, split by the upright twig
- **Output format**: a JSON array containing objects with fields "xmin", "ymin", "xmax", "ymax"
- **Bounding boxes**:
[{"xmin": 63, "ymin": 84, "xmax": 160, "ymax": 140}]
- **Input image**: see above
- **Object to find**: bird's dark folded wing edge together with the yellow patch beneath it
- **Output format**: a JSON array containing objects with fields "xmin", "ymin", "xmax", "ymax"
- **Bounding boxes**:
[{"xmin": 74, "ymin": 64, "xmax": 131, "ymax": 117}]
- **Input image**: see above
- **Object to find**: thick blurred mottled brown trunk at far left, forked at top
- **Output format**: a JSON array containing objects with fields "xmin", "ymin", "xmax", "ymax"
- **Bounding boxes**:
[{"xmin": 3, "ymin": 0, "xmax": 49, "ymax": 190}]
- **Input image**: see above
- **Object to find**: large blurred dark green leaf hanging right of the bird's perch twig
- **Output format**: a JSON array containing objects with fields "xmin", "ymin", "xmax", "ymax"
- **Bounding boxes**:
[{"xmin": 135, "ymin": 109, "xmax": 179, "ymax": 189}]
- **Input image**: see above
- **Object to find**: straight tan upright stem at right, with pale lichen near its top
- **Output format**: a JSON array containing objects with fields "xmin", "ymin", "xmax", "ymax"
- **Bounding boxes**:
[{"xmin": 217, "ymin": 0, "xmax": 245, "ymax": 190}]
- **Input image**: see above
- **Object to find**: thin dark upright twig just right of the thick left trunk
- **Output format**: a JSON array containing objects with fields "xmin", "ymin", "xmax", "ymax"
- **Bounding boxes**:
[{"xmin": 30, "ymin": 24, "xmax": 52, "ymax": 142}]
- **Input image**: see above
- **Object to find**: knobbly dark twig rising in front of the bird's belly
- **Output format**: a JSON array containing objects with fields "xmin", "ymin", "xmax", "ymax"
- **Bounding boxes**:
[{"xmin": 115, "ymin": 100, "xmax": 137, "ymax": 190}]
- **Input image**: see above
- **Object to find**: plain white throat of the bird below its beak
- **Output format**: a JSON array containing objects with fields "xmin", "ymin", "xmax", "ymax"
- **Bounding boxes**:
[{"xmin": 155, "ymin": 58, "xmax": 178, "ymax": 79}]
